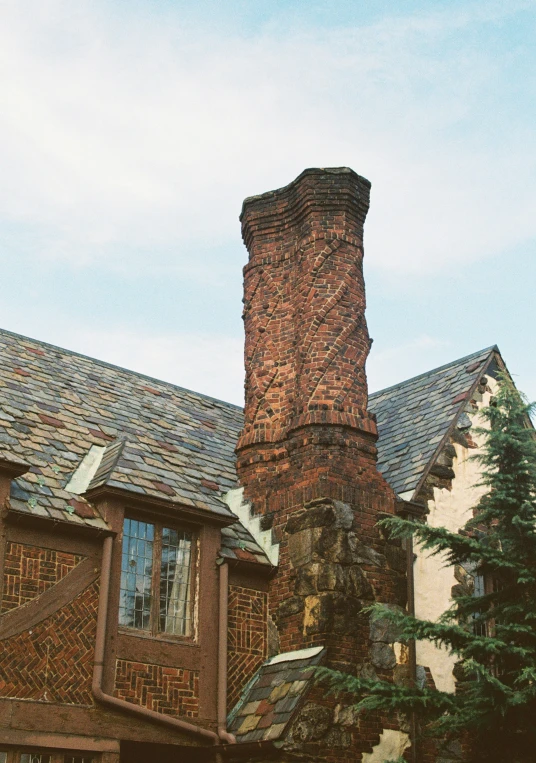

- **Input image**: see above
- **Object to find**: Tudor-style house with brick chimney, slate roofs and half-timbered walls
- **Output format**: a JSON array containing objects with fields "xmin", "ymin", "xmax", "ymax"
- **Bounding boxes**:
[{"xmin": 0, "ymin": 168, "xmax": 504, "ymax": 763}]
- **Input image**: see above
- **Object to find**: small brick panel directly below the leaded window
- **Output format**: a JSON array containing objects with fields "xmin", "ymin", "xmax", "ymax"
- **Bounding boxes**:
[{"xmin": 114, "ymin": 660, "xmax": 199, "ymax": 718}]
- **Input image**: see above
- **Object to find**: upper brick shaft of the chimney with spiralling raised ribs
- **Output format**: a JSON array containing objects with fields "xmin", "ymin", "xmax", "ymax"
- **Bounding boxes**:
[{"xmin": 238, "ymin": 171, "xmax": 376, "ymax": 449}]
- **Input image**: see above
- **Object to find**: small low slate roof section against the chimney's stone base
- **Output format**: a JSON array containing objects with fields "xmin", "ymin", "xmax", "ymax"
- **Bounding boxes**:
[{"xmin": 227, "ymin": 647, "xmax": 325, "ymax": 742}]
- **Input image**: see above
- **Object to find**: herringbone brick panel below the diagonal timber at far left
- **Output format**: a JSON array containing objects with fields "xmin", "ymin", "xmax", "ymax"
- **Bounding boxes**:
[{"xmin": 0, "ymin": 583, "xmax": 99, "ymax": 705}]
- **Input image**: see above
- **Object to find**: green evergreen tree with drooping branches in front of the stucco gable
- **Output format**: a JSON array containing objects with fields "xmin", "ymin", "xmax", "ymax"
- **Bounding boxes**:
[{"xmin": 319, "ymin": 375, "xmax": 536, "ymax": 763}]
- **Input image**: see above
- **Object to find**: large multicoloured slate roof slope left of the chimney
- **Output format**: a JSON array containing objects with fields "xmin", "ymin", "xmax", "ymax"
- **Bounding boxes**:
[{"xmin": 0, "ymin": 331, "xmax": 243, "ymax": 532}]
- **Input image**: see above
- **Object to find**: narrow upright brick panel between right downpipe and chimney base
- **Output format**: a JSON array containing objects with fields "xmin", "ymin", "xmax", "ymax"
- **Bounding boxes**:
[{"xmin": 227, "ymin": 585, "xmax": 268, "ymax": 709}]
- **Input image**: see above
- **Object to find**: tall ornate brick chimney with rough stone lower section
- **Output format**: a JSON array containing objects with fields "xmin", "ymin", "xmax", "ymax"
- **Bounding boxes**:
[{"xmin": 236, "ymin": 167, "xmax": 404, "ymax": 672}]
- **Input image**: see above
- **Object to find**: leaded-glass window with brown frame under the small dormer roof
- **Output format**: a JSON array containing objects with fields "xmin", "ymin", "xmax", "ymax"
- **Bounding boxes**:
[{"xmin": 119, "ymin": 518, "xmax": 193, "ymax": 637}]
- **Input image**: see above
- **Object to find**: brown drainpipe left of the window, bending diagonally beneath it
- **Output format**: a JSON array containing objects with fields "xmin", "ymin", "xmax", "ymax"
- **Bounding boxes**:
[{"xmin": 91, "ymin": 536, "xmax": 220, "ymax": 748}]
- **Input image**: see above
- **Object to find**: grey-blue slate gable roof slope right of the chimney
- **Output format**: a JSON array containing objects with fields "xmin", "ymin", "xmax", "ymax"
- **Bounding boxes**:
[{"xmin": 369, "ymin": 346, "xmax": 498, "ymax": 494}]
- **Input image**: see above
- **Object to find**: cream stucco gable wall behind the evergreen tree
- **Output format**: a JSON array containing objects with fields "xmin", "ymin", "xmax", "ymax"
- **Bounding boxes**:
[{"xmin": 415, "ymin": 377, "xmax": 497, "ymax": 692}]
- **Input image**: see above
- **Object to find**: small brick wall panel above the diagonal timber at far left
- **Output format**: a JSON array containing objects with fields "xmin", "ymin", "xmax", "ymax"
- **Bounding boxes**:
[{"xmin": 0, "ymin": 541, "xmax": 84, "ymax": 612}]
